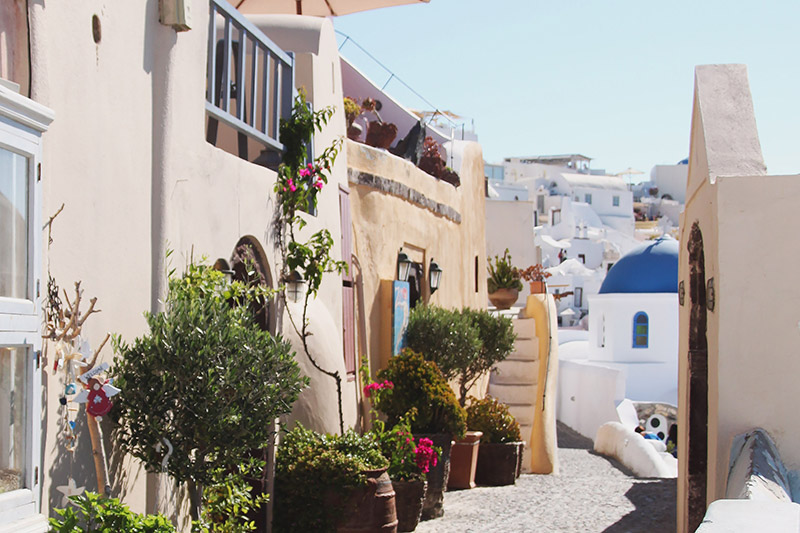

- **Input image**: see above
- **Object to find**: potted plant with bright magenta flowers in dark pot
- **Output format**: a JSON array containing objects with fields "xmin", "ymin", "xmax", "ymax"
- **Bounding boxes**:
[{"xmin": 370, "ymin": 412, "xmax": 441, "ymax": 532}]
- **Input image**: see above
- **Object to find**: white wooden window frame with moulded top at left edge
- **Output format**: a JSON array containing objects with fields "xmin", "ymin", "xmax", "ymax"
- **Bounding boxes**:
[{"xmin": 0, "ymin": 84, "xmax": 54, "ymax": 533}]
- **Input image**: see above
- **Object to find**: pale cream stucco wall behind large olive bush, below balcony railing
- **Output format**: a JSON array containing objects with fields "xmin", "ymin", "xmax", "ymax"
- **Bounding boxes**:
[{"xmin": 31, "ymin": 0, "xmax": 355, "ymax": 512}]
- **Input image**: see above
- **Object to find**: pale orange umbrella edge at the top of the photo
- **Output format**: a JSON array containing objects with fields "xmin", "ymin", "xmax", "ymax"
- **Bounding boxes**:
[{"xmin": 231, "ymin": 0, "xmax": 430, "ymax": 17}]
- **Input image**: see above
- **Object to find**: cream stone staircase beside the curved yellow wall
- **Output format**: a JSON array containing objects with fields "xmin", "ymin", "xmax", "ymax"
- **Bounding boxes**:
[{"xmin": 489, "ymin": 318, "xmax": 539, "ymax": 472}]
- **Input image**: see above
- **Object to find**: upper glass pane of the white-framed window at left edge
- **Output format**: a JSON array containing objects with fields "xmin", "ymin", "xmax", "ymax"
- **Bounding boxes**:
[{"xmin": 0, "ymin": 148, "xmax": 30, "ymax": 298}]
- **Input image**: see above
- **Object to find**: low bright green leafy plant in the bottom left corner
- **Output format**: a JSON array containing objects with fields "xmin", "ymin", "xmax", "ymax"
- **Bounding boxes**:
[{"xmin": 50, "ymin": 492, "xmax": 175, "ymax": 533}]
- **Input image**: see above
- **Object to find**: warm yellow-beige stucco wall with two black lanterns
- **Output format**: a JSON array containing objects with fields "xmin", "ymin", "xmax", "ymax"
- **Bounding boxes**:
[{"xmin": 347, "ymin": 137, "xmax": 487, "ymax": 378}]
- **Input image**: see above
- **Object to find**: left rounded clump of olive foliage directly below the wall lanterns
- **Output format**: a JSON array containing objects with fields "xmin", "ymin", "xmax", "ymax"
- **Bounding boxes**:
[{"xmin": 406, "ymin": 305, "xmax": 481, "ymax": 381}]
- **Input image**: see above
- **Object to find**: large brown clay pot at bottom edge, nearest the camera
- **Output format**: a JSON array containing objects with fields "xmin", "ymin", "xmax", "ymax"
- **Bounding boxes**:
[{"xmin": 336, "ymin": 468, "xmax": 397, "ymax": 533}]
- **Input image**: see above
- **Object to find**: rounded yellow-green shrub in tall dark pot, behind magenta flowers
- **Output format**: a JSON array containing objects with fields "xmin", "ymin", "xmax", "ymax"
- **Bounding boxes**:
[{"xmin": 375, "ymin": 349, "xmax": 467, "ymax": 520}]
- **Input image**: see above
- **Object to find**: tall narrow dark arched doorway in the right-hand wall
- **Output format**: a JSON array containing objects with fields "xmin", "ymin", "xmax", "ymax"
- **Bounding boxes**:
[{"xmin": 686, "ymin": 222, "xmax": 708, "ymax": 531}]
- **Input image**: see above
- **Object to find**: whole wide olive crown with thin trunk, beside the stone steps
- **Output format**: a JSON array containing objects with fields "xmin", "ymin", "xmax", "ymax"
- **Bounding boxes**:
[{"xmin": 406, "ymin": 306, "xmax": 516, "ymax": 406}]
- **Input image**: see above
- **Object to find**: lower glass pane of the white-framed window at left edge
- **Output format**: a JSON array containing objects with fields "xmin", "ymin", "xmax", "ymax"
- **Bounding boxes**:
[{"xmin": 0, "ymin": 347, "xmax": 28, "ymax": 494}]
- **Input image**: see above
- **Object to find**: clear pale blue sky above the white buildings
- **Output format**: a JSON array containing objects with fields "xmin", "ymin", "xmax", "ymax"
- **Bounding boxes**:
[{"xmin": 334, "ymin": 0, "xmax": 800, "ymax": 174}]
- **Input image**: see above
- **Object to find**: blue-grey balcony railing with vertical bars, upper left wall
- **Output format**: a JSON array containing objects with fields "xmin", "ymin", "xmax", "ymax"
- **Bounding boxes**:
[{"xmin": 206, "ymin": 0, "xmax": 294, "ymax": 159}]
